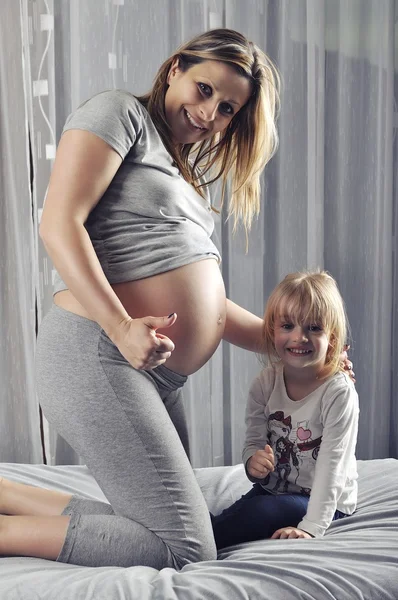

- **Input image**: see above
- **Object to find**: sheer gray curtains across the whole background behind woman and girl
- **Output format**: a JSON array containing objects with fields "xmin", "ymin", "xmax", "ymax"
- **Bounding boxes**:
[{"xmin": 0, "ymin": 0, "xmax": 398, "ymax": 466}]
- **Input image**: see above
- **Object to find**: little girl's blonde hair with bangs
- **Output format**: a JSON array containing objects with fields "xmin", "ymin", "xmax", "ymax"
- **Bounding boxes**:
[{"xmin": 264, "ymin": 270, "xmax": 349, "ymax": 379}]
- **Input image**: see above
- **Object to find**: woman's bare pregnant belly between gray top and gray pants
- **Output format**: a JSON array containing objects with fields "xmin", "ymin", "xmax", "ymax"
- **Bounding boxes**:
[{"xmin": 55, "ymin": 259, "xmax": 226, "ymax": 375}]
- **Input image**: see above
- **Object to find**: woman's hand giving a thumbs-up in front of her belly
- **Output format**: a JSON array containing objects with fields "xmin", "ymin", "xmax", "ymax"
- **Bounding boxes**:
[{"xmin": 109, "ymin": 313, "xmax": 177, "ymax": 370}]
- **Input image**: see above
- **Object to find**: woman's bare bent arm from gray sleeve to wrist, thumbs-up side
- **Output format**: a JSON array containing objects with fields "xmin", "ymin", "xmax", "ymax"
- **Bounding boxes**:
[{"xmin": 40, "ymin": 130, "xmax": 129, "ymax": 332}]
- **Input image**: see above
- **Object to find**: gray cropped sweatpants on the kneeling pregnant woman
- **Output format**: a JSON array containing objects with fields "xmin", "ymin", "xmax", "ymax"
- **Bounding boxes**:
[{"xmin": 36, "ymin": 305, "xmax": 216, "ymax": 569}]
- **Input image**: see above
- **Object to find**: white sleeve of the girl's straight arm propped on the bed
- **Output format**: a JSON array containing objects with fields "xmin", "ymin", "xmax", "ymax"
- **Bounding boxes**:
[{"xmin": 297, "ymin": 384, "xmax": 359, "ymax": 537}]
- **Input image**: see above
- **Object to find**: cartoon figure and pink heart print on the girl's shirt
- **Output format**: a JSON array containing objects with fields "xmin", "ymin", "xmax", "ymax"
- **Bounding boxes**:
[{"xmin": 265, "ymin": 410, "xmax": 322, "ymax": 495}]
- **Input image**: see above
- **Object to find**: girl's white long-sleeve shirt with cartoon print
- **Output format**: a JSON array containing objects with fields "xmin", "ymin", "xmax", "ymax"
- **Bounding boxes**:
[{"xmin": 242, "ymin": 363, "xmax": 359, "ymax": 537}]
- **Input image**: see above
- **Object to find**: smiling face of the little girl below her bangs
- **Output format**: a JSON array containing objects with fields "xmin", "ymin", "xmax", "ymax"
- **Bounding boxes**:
[{"xmin": 274, "ymin": 314, "xmax": 329, "ymax": 375}]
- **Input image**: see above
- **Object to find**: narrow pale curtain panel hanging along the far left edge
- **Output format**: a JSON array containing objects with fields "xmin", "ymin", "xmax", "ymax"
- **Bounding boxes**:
[{"xmin": 0, "ymin": 1, "xmax": 42, "ymax": 463}]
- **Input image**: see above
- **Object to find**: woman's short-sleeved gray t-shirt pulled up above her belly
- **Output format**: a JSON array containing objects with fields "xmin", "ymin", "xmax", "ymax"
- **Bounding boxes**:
[{"xmin": 54, "ymin": 90, "xmax": 221, "ymax": 293}]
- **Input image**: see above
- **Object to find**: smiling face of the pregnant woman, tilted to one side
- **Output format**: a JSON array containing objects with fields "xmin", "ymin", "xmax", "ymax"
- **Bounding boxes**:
[{"xmin": 165, "ymin": 60, "xmax": 252, "ymax": 144}]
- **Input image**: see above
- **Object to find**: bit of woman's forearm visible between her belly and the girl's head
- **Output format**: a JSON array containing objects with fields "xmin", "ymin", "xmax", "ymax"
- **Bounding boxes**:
[{"xmin": 223, "ymin": 299, "xmax": 264, "ymax": 353}]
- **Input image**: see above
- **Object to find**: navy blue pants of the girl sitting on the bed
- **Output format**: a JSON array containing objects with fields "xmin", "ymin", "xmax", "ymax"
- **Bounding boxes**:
[{"xmin": 211, "ymin": 483, "xmax": 346, "ymax": 549}]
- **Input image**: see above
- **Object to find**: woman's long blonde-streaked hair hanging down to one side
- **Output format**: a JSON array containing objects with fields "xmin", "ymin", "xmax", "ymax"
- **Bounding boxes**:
[{"xmin": 138, "ymin": 29, "xmax": 280, "ymax": 233}]
